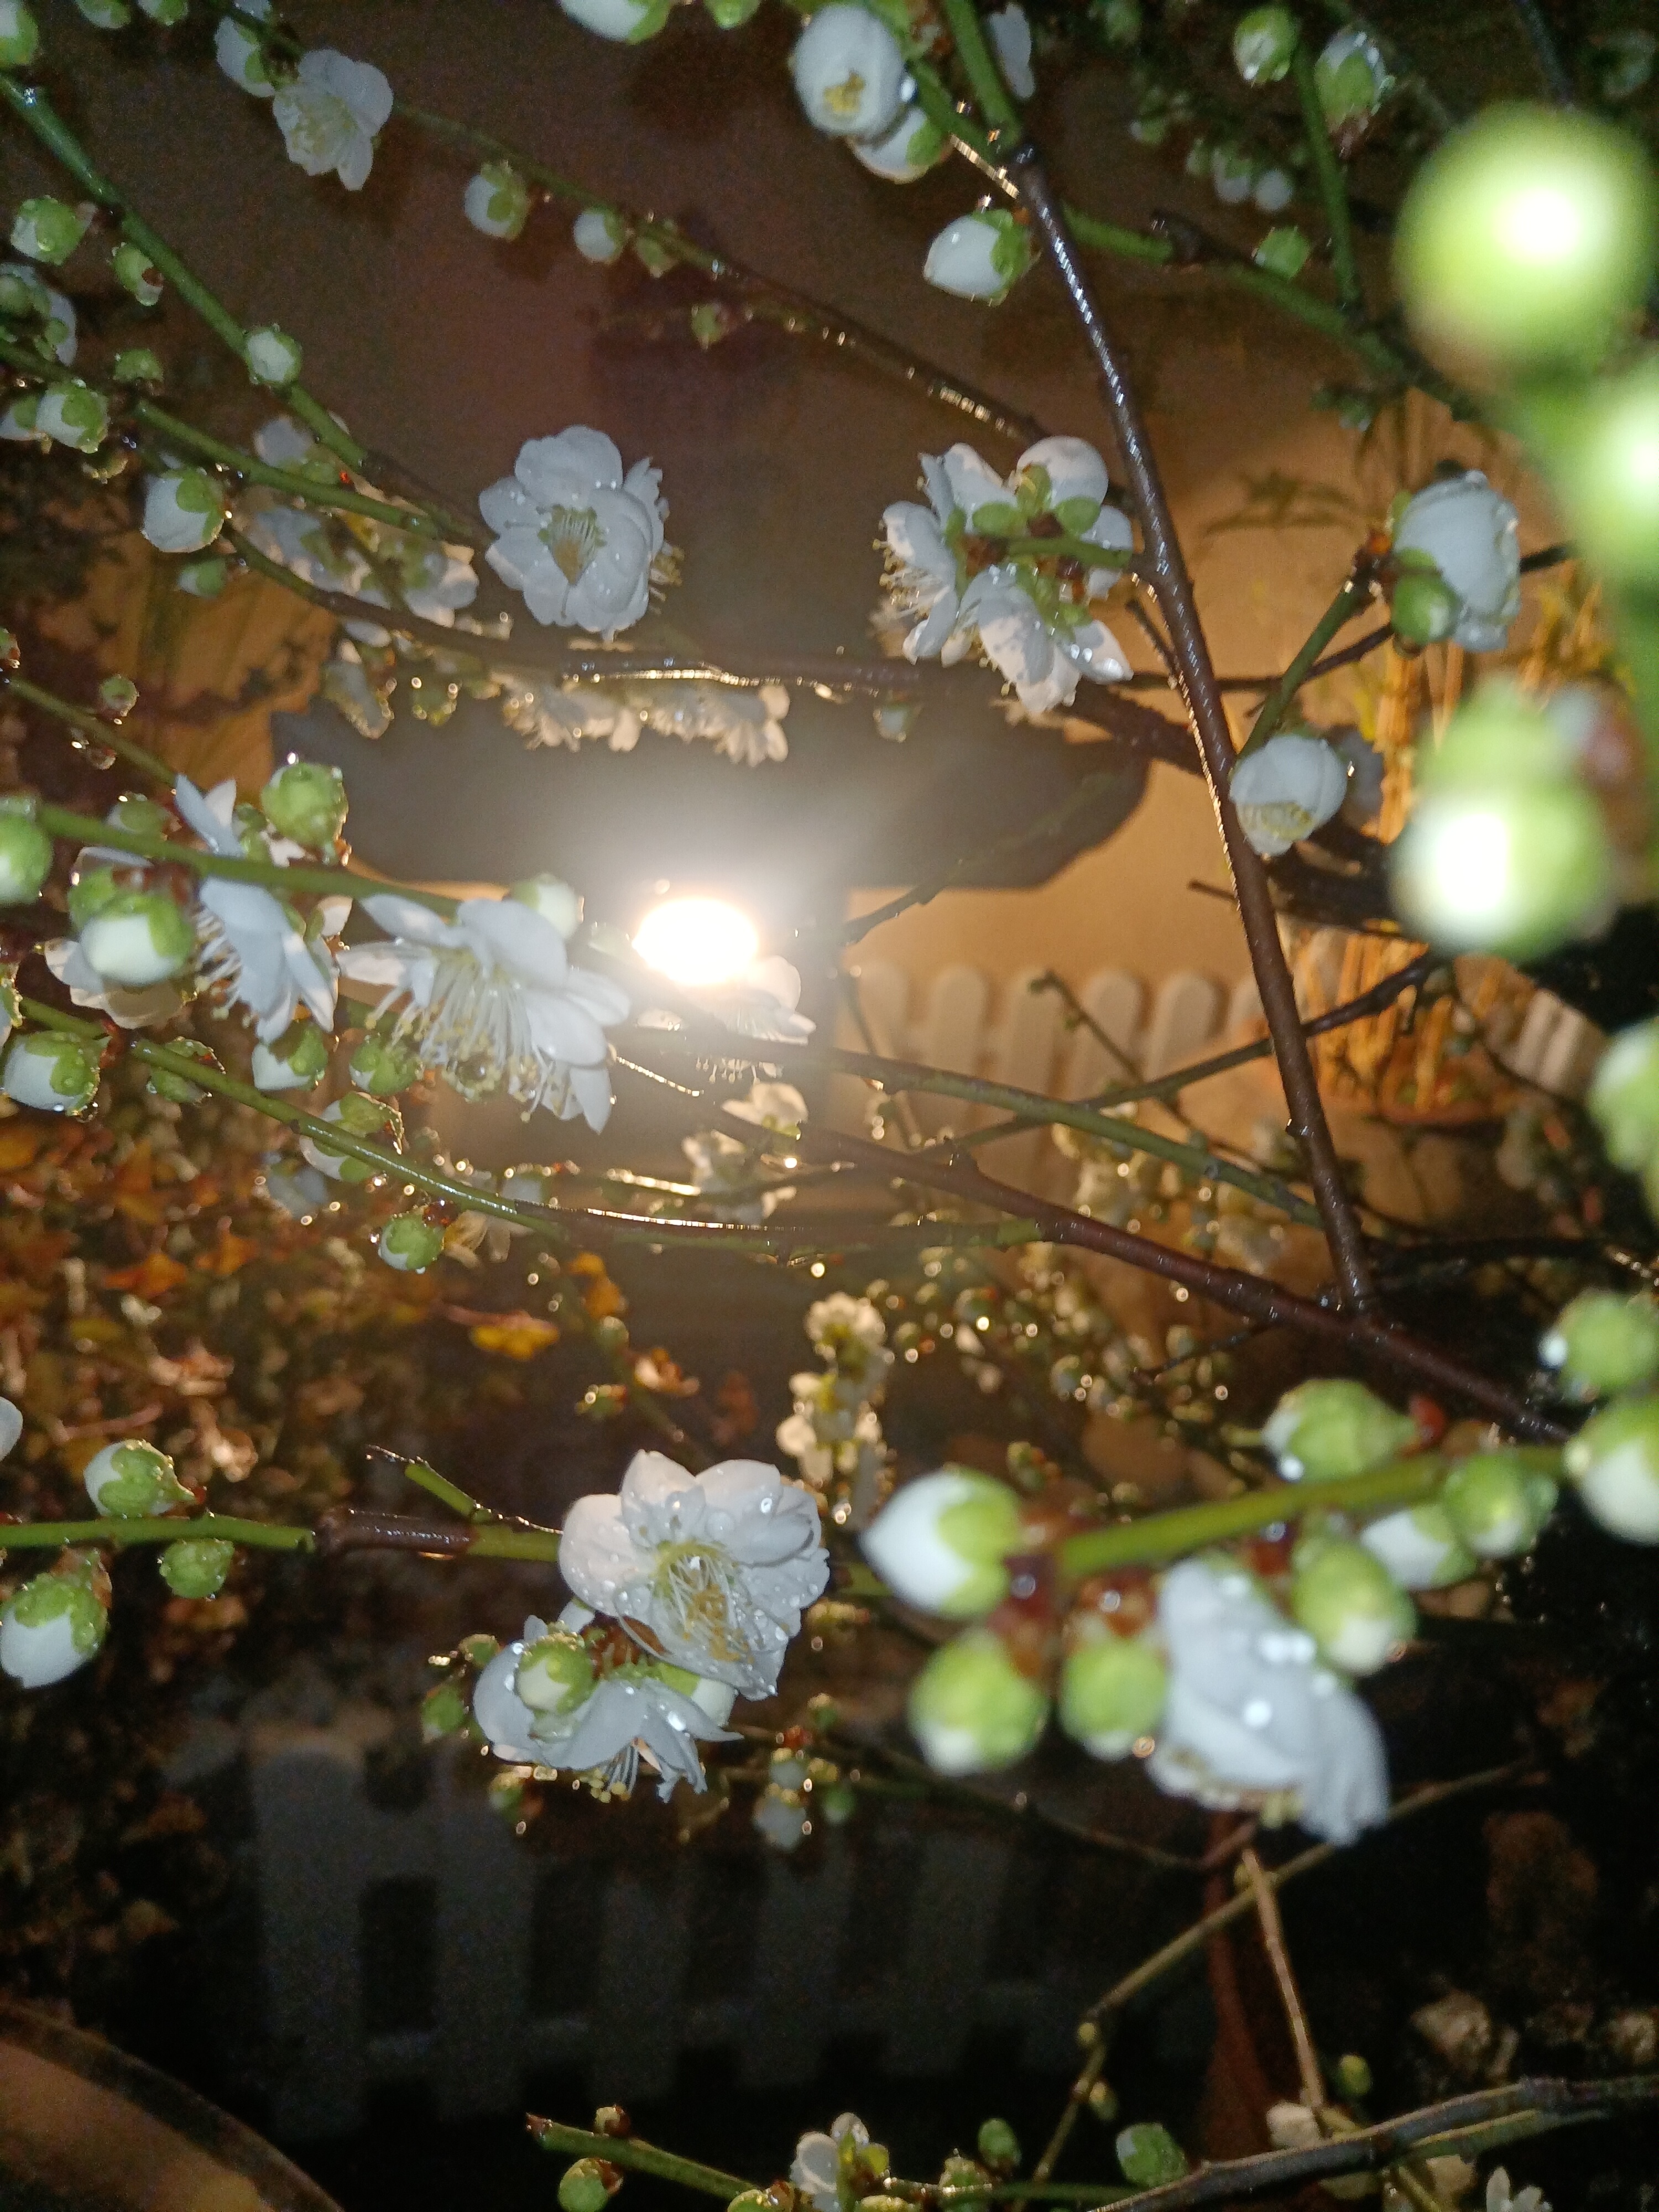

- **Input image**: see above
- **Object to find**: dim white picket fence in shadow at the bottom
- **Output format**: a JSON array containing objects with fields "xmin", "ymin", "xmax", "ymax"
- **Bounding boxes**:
[{"xmin": 246, "ymin": 1714, "xmax": 1095, "ymax": 2141}]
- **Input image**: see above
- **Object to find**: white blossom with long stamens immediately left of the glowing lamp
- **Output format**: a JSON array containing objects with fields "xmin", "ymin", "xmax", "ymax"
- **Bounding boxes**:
[{"xmin": 341, "ymin": 894, "xmax": 628, "ymax": 1128}]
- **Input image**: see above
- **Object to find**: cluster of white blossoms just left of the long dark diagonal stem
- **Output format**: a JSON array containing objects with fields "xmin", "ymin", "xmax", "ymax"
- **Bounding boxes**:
[{"xmin": 883, "ymin": 438, "xmax": 1135, "ymax": 714}]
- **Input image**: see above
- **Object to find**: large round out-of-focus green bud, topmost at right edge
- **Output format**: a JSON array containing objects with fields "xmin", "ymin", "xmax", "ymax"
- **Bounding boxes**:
[{"xmin": 1394, "ymin": 106, "xmax": 1659, "ymax": 374}]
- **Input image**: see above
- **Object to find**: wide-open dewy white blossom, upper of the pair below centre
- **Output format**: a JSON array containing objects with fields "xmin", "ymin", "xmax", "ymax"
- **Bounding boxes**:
[{"xmin": 560, "ymin": 1451, "xmax": 830, "ymax": 1697}]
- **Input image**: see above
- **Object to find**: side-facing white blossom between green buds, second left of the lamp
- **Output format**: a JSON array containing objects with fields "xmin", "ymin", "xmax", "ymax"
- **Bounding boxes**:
[{"xmin": 173, "ymin": 776, "xmax": 334, "ymax": 1044}]
